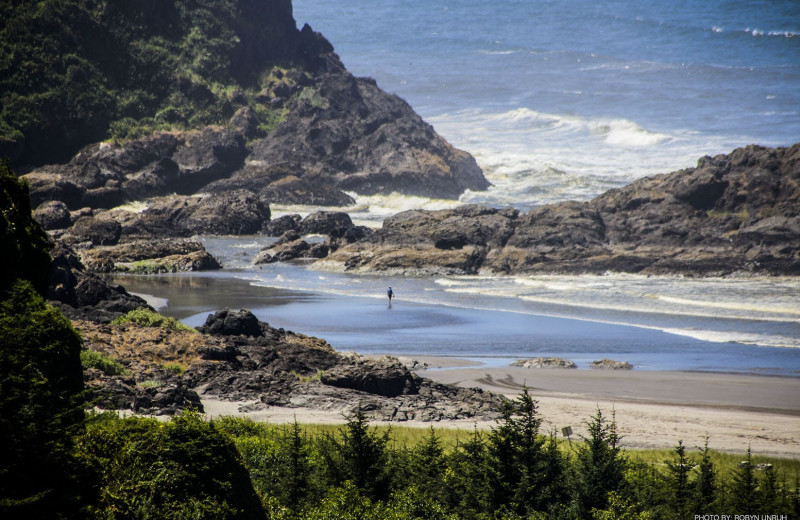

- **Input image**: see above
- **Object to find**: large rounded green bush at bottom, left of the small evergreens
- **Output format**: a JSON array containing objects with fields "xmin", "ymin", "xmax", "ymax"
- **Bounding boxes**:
[{"xmin": 79, "ymin": 412, "xmax": 265, "ymax": 520}]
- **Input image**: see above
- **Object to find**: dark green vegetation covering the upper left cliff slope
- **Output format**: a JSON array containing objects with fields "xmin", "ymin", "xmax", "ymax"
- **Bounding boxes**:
[{"xmin": 0, "ymin": 0, "xmax": 332, "ymax": 164}]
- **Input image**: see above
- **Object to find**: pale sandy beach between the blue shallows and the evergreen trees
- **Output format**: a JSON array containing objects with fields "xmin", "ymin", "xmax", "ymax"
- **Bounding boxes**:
[{"xmin": 204, "ymin": 357, "xmax": 800, "ymax": 457}]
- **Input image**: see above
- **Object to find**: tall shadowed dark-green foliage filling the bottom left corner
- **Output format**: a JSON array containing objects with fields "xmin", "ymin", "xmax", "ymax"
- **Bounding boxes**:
[{"xmin": 0, "ymin": 281, "xmax": 84, "ymax": 518}]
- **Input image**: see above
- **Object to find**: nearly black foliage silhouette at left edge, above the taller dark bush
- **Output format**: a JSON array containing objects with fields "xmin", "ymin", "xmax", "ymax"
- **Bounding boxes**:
[{"xmin": 0, "ymin": 157, "xmax": 51, "ymax": 298}]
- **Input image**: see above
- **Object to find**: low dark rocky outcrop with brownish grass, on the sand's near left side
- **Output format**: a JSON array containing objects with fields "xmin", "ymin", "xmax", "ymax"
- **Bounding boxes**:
[{"xmin": 75, "ymin": 309, "xmax": 502, "ymax": 421}]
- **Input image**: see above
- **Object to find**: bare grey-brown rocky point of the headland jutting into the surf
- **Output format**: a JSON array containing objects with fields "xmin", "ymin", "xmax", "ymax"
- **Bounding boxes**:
[{"xmin": 244, "ymin": 71, "xmax": 489, "ymax": 198}]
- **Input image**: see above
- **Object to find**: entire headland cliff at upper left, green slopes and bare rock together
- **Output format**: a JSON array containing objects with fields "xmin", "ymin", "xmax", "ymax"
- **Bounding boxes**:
[{"xmin": 0, "ymin": 0, "xmax": 488, "ymax": 203}]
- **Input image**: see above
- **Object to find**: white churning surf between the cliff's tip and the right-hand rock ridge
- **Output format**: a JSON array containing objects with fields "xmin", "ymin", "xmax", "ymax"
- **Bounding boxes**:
[{"xmin": 429, "ymin": 107, "xmax": 734, "ymax": 210}]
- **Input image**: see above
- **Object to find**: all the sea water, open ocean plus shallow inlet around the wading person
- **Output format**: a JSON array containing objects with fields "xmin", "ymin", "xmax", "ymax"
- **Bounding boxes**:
[{"xmin": 120, "ymin": 0, "xmax": 800, "ymax": 377}]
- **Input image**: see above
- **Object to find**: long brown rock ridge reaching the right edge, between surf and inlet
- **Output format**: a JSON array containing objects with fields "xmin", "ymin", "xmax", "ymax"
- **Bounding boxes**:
[{"xmin": 319, "ymin": 144, "xmax": 800, "ymax": 276}]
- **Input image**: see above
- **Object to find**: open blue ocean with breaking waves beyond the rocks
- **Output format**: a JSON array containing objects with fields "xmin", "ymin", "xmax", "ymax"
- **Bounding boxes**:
[{"xmin": 293, "ymin": 0, "xmax": 800, "ymax": 209}]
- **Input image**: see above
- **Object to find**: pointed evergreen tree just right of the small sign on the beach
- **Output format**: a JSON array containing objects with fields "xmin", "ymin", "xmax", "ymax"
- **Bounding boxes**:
[{"xmin": 575, "ymin": 408, "xmax": 626, "ymax": 516}]
